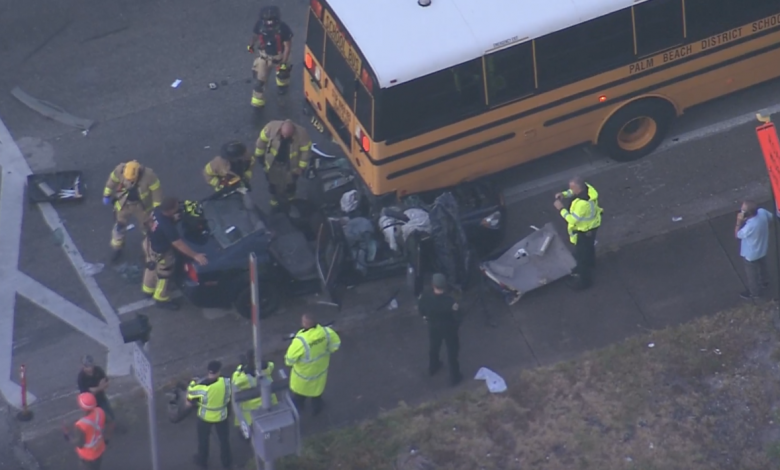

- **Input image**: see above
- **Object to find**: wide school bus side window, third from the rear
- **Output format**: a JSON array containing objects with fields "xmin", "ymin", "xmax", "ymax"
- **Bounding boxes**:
[{"xmin": 536, "ymin": 9, "xmax": 634, "ymax": 89}]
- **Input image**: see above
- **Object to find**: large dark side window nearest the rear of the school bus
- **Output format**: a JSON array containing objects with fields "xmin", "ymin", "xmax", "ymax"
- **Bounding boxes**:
[{"xmin": 374, "ymin": 58, "xmax": 485, "ymax": 141}]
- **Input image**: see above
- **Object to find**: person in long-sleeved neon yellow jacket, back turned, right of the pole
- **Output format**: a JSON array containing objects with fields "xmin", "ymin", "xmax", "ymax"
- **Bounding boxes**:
[{"xmin": 284, "ymin": 313, "xmax": 341, "ymax": 416}]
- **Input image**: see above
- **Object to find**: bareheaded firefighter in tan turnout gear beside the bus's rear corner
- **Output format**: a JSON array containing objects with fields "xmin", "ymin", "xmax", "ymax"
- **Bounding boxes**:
[{"xmin": 255, "ymin": 119, "xmax": 311, "ymax": 209}]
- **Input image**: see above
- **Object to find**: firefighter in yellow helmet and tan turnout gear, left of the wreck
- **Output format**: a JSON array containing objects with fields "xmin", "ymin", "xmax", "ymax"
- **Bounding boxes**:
[{"xmin": 103, "ymin": 160, "xmax": 162, "ymax": 261}]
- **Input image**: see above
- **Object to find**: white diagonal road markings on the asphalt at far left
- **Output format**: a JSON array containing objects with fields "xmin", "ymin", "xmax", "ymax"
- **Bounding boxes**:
[{"xmin": 0, "ymin": 115, "xmax": 132, "ymax": 407}]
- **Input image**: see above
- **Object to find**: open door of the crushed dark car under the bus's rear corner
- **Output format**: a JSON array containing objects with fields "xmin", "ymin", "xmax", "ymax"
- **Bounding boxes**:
[{"xmin": 315, "ymin": 219, "xmax": 347, "ymax": 307}]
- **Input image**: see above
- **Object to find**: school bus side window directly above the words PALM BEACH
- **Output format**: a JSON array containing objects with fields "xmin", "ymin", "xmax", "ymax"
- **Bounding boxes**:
[{"xmin": 634, "ymin": 0, "xmax": 685, "ymax": 57}]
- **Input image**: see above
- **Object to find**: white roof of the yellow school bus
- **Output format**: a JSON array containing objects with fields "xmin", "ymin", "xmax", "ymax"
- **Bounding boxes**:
[{"xmin": 326, "ymin": 0, "xmax": 646, "ymax": 88}]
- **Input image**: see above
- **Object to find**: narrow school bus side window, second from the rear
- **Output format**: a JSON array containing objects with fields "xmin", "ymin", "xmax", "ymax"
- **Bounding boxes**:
[{"xmin": 485, "ymin": 41, "xmax": 535, "ymax": 106}]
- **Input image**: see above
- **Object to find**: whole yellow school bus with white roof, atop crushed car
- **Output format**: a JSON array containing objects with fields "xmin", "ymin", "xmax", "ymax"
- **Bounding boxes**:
[{"xmin": 304, "ymin": 0, "xmax": 780, "ymax": 196}]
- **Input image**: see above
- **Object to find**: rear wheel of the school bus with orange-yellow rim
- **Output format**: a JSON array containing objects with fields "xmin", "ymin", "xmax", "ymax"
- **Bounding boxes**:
[{"xmin": 597, "ymin": 99, "xmax": 675, "ymax": 162}]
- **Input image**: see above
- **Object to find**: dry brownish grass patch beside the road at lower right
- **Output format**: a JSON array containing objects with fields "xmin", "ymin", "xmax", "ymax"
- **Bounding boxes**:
[{"xmin": 278, "ymin": 306, "xmax": 780, "ymax": 470}]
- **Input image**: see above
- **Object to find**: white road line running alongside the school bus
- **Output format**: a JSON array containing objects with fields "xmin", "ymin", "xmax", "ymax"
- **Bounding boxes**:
[{"xmin": 504, "ymin": 104, "xmax": 780, "ymax": 204}]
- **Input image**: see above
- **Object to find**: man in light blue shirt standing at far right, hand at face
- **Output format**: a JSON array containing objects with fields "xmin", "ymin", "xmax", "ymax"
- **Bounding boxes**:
[{"xmin": 734, "ymin": 201, "xmax": 772, "ymax": 300}]
